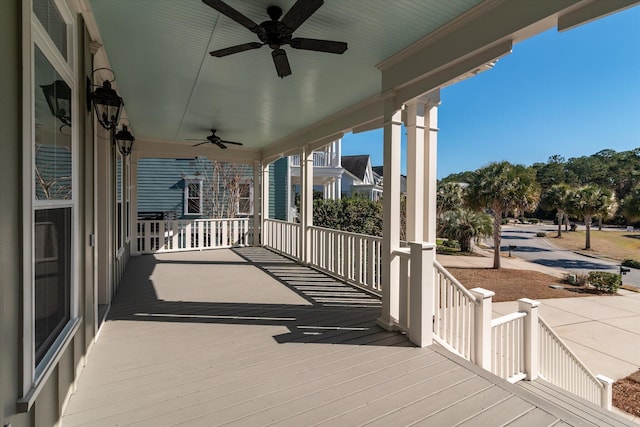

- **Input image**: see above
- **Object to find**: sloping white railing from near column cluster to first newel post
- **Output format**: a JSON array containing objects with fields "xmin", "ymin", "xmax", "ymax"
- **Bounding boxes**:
[{"xmin": 433, "ymin": 261, "xmax": 477, "ymax": 360}]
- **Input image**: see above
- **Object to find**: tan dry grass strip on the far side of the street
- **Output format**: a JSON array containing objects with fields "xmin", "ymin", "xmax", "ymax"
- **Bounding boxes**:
[{"xmin": 547, "ymin": 229, "xmax": 640, "ymax": 261}]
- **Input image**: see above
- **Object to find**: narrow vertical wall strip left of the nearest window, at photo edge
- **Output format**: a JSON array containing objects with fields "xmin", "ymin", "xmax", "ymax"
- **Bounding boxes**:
[{"xmin": 0, "ymin": 0, "xmax": 22, "ymax": 426}]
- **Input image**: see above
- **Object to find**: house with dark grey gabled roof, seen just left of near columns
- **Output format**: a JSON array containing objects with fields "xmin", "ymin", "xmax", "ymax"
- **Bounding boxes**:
[{"xmin": 342, "ymin": 154, "xmax": 382, "ymax": 201}]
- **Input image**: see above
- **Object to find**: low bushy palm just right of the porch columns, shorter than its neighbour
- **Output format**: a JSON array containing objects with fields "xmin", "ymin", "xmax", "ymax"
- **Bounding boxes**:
[{"xmin": 438, "ymin": 208, "xmax": 493, "ymax": 252}]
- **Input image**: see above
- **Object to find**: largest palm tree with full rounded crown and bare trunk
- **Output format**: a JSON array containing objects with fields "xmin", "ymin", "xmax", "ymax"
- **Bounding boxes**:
[{"xmin": 467, "ymin": 161, "xmax": 540, "ymax": 269}]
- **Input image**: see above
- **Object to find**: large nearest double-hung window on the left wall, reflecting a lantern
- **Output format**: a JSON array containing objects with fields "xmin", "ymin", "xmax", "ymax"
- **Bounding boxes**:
[{"xmin": 27, "ymin": 0, "xmax": 78, "ymax": 386}]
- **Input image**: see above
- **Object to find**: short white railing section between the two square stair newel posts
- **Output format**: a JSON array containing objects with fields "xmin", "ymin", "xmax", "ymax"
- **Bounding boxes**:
[{"xmin": 491, "ymin": 311, "xmax": 527, "ymax": 383}]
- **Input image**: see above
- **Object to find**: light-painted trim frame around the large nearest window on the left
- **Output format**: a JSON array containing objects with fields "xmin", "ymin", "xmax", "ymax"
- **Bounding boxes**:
[{"xmin": 17, "ymin": 0, "xmax": 81, "ymax": 402}]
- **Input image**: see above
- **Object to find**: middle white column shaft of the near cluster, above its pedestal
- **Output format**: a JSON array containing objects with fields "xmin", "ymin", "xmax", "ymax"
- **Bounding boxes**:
[{"xmin": 404, "ymin": 99, "xmax": 426, "ymax": 242}]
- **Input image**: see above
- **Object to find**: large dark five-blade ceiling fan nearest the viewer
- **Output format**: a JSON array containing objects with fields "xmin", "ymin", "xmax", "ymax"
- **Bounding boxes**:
[{"xmin": 202, "ymin": 0, "xmax": 347, "ymax": 78}]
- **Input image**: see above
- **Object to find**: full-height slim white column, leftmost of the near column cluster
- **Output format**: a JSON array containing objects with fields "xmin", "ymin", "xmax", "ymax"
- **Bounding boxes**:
[{"xmin": 378, "ymin": 94, "xmax": 402, "ymax": 330}]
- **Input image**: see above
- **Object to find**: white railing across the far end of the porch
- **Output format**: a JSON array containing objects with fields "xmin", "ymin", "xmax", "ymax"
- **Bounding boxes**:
[{"xmin": 134, "ymin": 218, "xmax": 252, "ymax": 254}]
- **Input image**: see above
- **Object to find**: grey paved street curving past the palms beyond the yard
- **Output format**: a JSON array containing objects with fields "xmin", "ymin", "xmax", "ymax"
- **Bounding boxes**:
[{"xmin": 500, "ymin": 224, "xmax": 640, "ymax": 288}]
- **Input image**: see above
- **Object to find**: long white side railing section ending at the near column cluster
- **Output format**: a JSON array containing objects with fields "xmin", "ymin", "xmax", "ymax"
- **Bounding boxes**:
[{"xmin": 309, "ymin": 226, "xmax": 382, "ymax": 295}]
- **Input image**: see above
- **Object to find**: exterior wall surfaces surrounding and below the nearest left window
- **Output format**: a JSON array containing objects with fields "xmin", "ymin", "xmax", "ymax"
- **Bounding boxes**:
[{"xmin": 0, "ymin": 4, "xmax": 95, "ymax": 427}]
